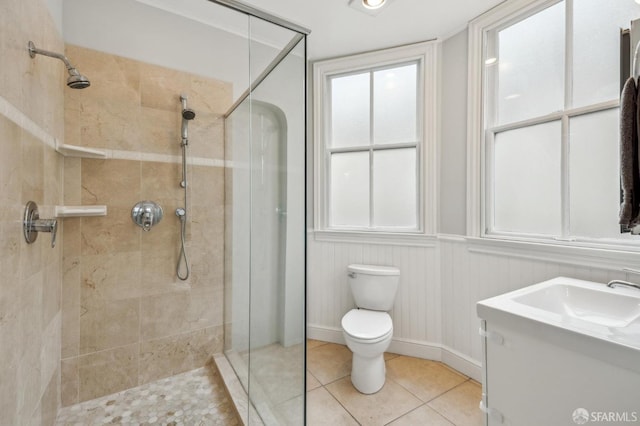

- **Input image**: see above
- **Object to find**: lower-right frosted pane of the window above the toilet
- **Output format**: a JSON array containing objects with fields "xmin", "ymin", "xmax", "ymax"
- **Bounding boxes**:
[{"xmin": 373, "ymin": 148, "xmax": 417, "ymax": 228}]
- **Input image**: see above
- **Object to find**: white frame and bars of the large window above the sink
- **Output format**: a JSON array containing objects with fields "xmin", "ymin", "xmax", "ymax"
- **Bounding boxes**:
[{"xmin": 467, "ymin": 0, "xmax": 640, "ymax": 256}]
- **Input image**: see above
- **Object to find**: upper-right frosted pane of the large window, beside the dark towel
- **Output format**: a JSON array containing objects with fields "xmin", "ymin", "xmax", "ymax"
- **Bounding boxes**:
[{"xmin": 573, "ymin": 0, "xmax": 640, "ymax": 107}]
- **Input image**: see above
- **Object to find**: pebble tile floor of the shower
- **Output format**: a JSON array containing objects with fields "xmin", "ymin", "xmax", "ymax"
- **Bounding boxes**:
[{"xmin": 56, "ymin": 367, "xmax": 240, "ymax": 426}]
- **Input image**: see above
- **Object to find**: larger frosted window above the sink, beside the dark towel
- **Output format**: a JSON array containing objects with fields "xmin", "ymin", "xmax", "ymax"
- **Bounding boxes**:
[{"xmin": 468, "ymin": 0, "xmax": 640, "ymax": 243}]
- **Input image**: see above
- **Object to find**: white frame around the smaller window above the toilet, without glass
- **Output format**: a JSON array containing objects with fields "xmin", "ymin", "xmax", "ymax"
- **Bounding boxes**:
[{"xmin": 313, "ymin": 41, "xmax": 440, "ymax": 241}]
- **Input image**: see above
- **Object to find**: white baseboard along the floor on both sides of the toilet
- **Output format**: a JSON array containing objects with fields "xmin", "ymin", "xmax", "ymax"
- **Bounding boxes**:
[{"xmin": 307, "ymin": 324, "xmax": 482, "ymax": 382}]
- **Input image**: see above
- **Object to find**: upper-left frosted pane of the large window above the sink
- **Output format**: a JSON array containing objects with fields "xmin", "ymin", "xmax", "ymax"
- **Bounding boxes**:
[{"xmin": 497, "ymin": 2, "xmax": 565, "ymax": 124}]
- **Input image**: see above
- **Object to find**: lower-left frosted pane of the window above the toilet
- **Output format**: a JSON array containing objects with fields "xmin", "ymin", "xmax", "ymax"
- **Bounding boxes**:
[{"xmin": 330, "ymin": 151, "xmax": 369, "ymax": 226}]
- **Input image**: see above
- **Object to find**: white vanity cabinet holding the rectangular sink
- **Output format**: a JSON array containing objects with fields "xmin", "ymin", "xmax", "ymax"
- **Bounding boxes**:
[{"xmin": 477, "ymin": 276, "xmax": 640, "ymax": 426}]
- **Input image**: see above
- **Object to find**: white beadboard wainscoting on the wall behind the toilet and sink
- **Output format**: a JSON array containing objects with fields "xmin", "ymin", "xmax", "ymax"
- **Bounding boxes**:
[{"xmin": 307, "ymin": 233, "xmax": 638, "ymax": 381}]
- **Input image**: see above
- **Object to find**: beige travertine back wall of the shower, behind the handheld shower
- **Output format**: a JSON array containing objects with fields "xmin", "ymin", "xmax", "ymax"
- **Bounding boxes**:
[{"xmin": 61, "ymin": 46, "xmax": 232, "ymax": 405}]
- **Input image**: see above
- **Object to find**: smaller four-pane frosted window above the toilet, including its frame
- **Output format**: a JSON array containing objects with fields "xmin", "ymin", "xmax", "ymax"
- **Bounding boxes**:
[{"xmin": 314, "ymin": 43, "xmax": 436, "ymax": 233}]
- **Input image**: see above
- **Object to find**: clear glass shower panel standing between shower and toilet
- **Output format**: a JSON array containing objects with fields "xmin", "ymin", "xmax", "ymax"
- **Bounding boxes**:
[{"xmin": 225, "ymin": 18, "xmax": 305, "ymax": 425}]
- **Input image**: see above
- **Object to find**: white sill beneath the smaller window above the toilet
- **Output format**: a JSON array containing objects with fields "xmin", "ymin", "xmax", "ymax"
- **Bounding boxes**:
[{"xmin": 312, "ymin": 229, "xmax": 438, "ymax": 247}]
